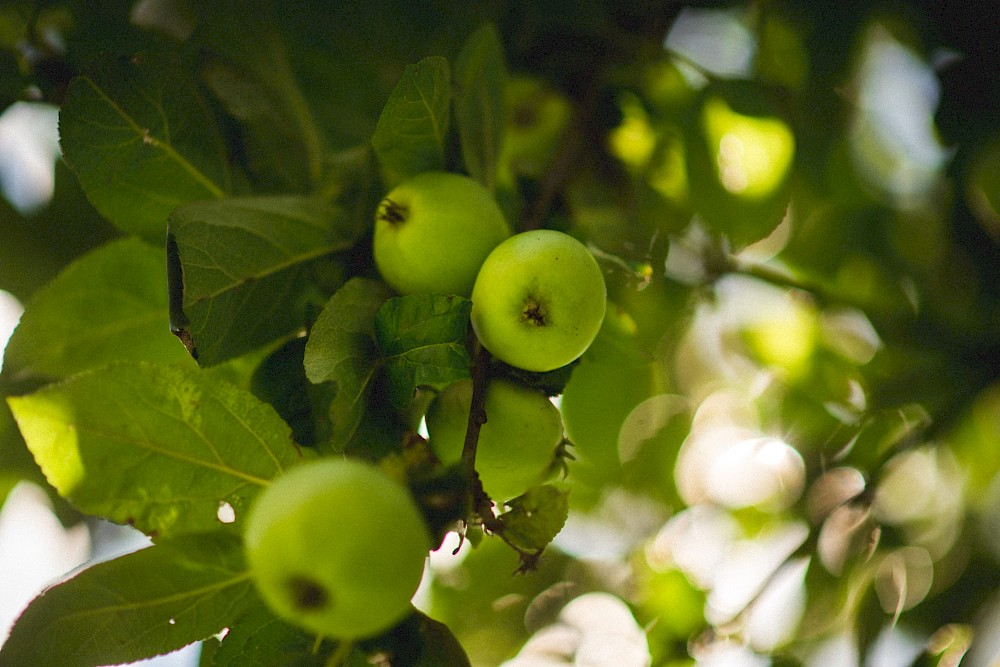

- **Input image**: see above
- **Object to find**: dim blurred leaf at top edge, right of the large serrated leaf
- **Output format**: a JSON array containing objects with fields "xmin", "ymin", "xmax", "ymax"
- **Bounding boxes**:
[{"xmin": 192, "ymin": 0, "xmax": 323, "ymax": 192}]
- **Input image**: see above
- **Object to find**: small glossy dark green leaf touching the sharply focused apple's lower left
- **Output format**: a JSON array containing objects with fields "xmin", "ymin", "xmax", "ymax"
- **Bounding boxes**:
[{"xmin": 375, "ymin": 294, "xmax": 472, "ymax": 408}]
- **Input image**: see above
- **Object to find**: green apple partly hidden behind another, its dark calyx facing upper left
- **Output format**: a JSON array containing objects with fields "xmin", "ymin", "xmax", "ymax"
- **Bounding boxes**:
[{"xmin": 373, "ymin": 171, "xmax": 510, "ymax": 296}]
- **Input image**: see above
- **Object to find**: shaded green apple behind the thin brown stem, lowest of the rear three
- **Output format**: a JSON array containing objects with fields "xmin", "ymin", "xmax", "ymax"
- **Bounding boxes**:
[{"xmin": 427, "ymin": 379, "xmax": 563, "ymax": 502}]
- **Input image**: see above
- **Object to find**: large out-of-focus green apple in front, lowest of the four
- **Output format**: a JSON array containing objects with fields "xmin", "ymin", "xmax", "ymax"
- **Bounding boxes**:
[{"xmin": 244, "ymin": 458, "xmax": 431, "ymax": 640}]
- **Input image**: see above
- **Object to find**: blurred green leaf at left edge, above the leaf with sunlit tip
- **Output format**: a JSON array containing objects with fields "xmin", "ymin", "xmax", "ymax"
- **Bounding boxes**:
[{"xmin": 4, "ymin": 239, "xmax": 190, "ymax": 380}]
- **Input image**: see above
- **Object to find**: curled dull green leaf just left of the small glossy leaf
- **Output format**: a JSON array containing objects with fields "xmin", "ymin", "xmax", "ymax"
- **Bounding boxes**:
[{"xmin": 303, "ymin": 278, "xmax": 390, "ymax": 446}]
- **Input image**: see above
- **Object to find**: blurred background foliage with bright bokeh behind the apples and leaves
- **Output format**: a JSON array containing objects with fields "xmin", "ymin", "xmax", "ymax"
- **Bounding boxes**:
[{"xmin": 0, "ymin": 0, "xmax": 1000, "ymax": 667}]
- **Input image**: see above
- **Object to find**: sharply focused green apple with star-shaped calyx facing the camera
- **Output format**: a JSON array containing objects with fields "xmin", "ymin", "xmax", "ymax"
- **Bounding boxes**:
[{"xmin": 472, "ymin": 229, "xmax": 607, "ymax": 372}]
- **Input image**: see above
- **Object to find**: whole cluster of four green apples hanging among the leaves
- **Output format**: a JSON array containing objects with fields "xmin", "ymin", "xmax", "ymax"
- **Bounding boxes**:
[{"xmin": 244, "ymin": 172, "xmax": 607, "ymax": 641}]
